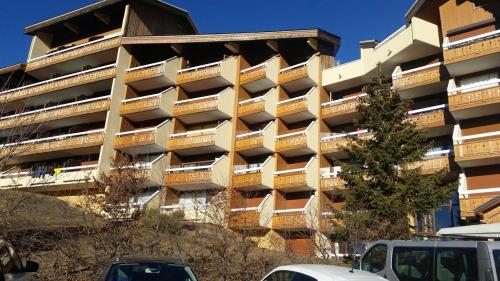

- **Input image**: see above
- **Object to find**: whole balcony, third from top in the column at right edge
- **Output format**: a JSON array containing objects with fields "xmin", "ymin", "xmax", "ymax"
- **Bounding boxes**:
[{"xmin": 453, "ymin": 131, "xmax": 500, "ymax": 168}]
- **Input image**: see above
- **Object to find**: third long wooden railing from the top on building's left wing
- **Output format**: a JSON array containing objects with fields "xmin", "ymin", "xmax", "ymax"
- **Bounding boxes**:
[{"xmin": 0, "ymin": 96, "xmax": 111, "ymax": 129}]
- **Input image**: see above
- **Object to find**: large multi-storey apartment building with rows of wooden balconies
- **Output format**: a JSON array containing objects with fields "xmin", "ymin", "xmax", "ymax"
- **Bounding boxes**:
[{"xmin": 0, "ymin": 0, "xmax": 500, "ymax": 254}]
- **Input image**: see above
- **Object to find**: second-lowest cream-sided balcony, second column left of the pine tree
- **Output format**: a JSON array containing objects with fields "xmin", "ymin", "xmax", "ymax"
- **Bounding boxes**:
[{"xmin": 233, "ymin": 156, "xmax": 276, "ymax": 191}]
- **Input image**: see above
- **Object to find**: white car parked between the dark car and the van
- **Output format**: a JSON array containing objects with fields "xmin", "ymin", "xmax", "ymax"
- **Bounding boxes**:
[{"xmin": 262, "ymin": 264, "xmax": 387, "ymax": 281}]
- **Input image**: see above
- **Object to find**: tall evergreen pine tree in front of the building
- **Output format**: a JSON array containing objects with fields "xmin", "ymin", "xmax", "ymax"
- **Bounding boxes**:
[{"xmin": 334, "ymin": 68, "xmax": 457, "ymax": 243}]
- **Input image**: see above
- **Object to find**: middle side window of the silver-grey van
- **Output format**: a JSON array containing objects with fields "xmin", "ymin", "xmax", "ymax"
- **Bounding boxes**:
[{"xmin": 392, "ymin": 247, "xmax": 434, "ymax": 281}]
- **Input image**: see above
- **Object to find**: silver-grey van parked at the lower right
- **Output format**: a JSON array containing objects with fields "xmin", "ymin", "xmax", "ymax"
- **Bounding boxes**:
[{"xmin": 359, "ymin": 240, "xmax": 500, "ymax": 281}]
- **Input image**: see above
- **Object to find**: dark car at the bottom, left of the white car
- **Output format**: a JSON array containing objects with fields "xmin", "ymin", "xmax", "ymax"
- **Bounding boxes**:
[{"xmin": 99, "ymin": 257, "xmax": 198, "ymax": 281}]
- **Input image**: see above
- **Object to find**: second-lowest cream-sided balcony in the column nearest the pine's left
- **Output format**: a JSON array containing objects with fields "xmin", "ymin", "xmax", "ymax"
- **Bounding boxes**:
[{"xmin": 274, "ymin": 157, "xmax": 318, "ymax": 192}]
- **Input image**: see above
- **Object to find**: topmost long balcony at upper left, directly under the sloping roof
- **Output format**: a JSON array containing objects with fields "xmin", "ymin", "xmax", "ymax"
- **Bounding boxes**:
[{"xmin": 26, "ymin": 33, "xmax": 121, "ymax": 79}]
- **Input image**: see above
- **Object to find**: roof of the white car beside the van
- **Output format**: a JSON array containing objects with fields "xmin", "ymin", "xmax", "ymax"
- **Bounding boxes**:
[{"xmin": 272, "ymin": 264, "xmax": 386, "ymax": 281}]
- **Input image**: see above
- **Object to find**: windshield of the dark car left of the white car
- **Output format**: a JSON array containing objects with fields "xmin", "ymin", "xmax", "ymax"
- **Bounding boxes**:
[{"xmin": 106, "ymin": 262, "xmax": 197, "ymax": 281}]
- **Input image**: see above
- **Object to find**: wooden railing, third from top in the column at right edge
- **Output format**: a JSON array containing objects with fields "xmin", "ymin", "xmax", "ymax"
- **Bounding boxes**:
[{"xmin": 455, "ymin": 135, "xmax": 500, "ymax": 162}]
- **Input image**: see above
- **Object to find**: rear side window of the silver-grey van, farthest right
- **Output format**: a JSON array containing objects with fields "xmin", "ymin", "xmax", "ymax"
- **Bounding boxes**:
[{"xmin": 436, "ymin": 248, "xmax": 478, "ymax": 281}]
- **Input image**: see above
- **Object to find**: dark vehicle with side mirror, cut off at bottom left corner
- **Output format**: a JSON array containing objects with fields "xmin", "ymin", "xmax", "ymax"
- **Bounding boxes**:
[{"xmin": 0, "ymin": 239, "xmax": 38, "ymax": 281}]
